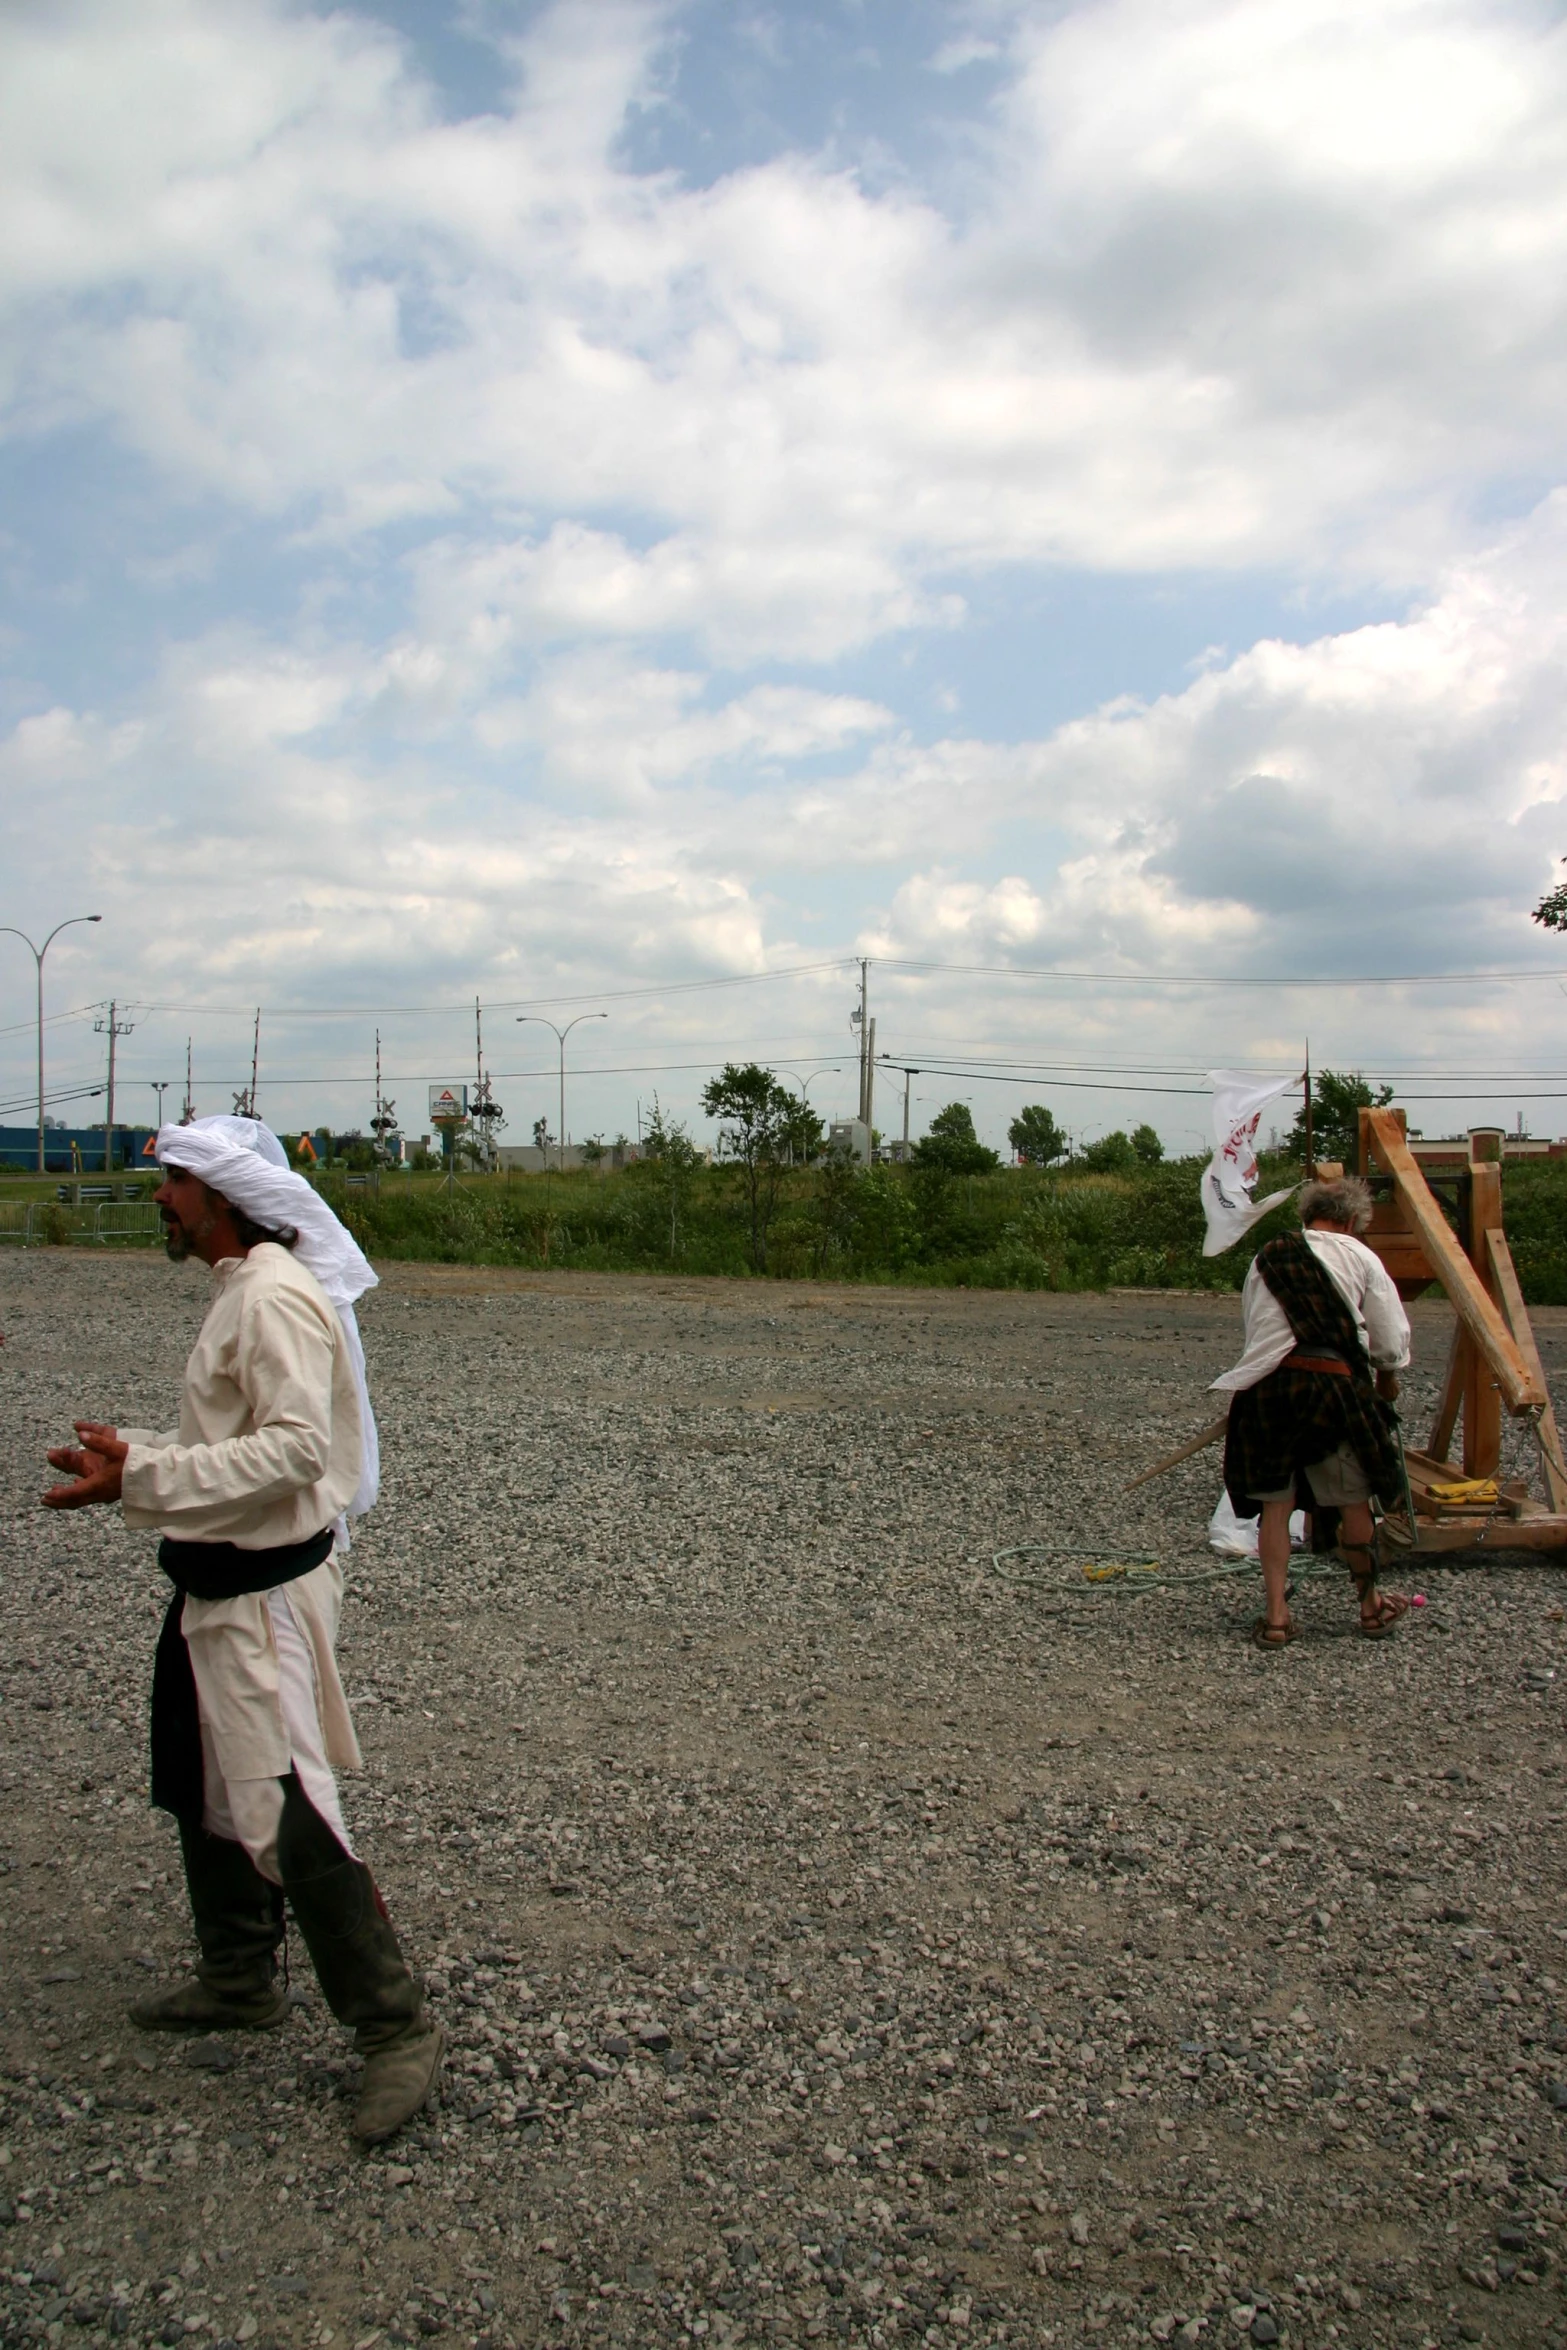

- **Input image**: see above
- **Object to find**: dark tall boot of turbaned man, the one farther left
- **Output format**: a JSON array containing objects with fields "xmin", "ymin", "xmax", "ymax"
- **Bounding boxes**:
[{"xmin": 132, "ymin": 1819, "xmax": 289, "ymax": 2033}]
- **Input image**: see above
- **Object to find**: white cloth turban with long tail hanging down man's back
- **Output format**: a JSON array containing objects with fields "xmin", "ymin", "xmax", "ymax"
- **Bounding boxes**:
[{"xmin": 157, "ymin": 1119, "xmax": 381, "ymax": 1542}]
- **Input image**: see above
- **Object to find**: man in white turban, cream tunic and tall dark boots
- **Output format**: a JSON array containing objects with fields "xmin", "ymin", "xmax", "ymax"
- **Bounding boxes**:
[{"xmin": 45, "ymin": 1119, "xmax": 442, "ymax": 2143}]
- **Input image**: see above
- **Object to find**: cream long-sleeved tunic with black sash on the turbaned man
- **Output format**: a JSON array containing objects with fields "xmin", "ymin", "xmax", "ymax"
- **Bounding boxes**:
[{"xmin": 117, "ymin": 1241, "xmax": 362, "ymax": 1781}]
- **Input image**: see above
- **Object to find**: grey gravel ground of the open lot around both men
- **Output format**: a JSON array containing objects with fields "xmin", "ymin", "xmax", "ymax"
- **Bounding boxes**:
[{"xmin": 0, "ymin": 1253, "xmax": 1567, "ymax": 2350}]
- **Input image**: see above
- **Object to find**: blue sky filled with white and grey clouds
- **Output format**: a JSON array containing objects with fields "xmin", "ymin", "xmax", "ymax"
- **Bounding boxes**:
[{"xmin": 0, "ymin": 0, "xmax": 1567, "ymax": 1149}]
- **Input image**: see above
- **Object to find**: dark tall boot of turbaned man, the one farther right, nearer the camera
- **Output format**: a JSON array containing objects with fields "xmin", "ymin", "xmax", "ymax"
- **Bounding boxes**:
[{"xmin": 277, "ymin": 1772, "xmax": 446, "ymax": 2146}]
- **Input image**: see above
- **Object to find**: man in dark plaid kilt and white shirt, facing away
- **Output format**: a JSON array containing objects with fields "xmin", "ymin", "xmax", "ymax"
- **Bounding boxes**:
[{"xmin": 1215, "ymin": 1175, "xmax": 1410, "ymax": 1647}]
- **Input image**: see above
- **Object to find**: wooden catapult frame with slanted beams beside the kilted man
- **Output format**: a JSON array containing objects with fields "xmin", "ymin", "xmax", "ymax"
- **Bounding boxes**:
[{"xmin": 1360, "ymin": 1109, "xmax": 1567, "ymax": 1551}]
